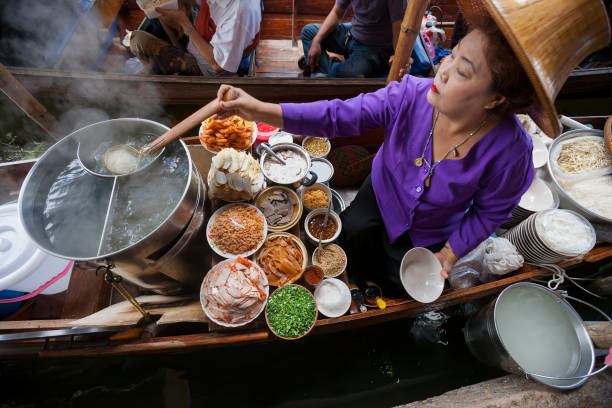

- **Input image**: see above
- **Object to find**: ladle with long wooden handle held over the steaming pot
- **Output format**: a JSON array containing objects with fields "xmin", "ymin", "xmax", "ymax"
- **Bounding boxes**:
[{"xmin": 77, "ymin": 99, "xmax": 221, "ymax": 177}]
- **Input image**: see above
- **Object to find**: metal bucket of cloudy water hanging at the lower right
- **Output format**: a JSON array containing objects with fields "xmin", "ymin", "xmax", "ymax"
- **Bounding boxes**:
[{"xmin": 464, "ymin": 282, "xmax": 601, "ymax": 389}]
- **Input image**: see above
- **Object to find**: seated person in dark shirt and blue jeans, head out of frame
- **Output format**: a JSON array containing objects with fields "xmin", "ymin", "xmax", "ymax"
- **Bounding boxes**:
[{"xmin": 299, "ymin": 0, "xmax": 404, "ymax": 78}]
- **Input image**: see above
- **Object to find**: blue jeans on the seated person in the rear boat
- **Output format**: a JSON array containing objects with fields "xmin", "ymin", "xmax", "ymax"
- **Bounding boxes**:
[{"xmin": 302, "ymin": 23, "xmax": 394, "ymax": 78}]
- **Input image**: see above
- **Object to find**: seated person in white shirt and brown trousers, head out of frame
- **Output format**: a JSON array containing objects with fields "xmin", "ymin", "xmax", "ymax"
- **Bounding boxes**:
[{"xmin": 130, "ymin": 0, "xmax": 261, "ymax": 76}]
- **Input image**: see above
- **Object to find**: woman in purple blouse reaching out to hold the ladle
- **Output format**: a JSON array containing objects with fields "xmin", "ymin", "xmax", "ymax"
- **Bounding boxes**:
[{"xmin": 219, "ymin": 20, "xmax": 534, "ymax": 295}]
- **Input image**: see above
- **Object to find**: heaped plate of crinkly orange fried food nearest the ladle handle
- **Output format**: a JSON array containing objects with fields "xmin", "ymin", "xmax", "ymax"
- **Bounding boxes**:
[{"xmin": 198, "ymin": 115, "xmax": 257, "ymax": 154}]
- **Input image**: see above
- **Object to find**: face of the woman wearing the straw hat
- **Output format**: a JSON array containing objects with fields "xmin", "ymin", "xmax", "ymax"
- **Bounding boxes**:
[{"xmin": 427, "ymin": 30, "xmax": 501, "ymax": 117}]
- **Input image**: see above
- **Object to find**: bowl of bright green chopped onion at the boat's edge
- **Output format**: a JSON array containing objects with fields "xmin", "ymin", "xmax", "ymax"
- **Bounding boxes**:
[{"xmin": 265, "ymin": 284, "xmax": 318, "ymax": 340}]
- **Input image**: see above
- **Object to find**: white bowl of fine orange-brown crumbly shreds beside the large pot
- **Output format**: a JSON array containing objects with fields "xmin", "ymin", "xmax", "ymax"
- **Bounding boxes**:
[{"xmin": 206, "ymin": 203, "xmax": 268, "ymax": 258}]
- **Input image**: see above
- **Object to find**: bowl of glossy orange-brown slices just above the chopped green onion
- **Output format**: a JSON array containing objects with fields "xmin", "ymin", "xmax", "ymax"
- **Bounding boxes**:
[{"xmin": 254, "ymin": 232, "xmax": 308, "ymax": 286}]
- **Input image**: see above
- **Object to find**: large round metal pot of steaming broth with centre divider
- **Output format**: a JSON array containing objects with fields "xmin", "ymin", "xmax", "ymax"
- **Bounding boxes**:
[{"xmin": 19, "ymin": 118, "xmax": 210, "ymax": 294}]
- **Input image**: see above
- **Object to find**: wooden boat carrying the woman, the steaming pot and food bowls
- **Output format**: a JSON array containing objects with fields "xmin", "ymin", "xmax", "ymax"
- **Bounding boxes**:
[{"xmin": 0, "ymin": 117, "xmax": 612, "ymax": 358}]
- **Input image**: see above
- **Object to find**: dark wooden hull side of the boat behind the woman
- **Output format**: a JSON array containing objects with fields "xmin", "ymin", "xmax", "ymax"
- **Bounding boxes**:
[{"xmin": 8, "ymin": 67, "xmax": 612, "ymax": 105}]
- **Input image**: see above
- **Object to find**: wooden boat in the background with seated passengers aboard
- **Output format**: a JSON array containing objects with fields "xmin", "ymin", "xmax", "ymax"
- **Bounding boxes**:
[{"xmin": 5, "ymin": 0, "xmax": 612, "ymax": 105}]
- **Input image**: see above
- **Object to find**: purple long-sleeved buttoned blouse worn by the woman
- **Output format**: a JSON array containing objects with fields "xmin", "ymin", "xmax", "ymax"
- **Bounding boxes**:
[{"xmin": 281, "ymin": 75, "xmax": 535, "ymax": 257}]
